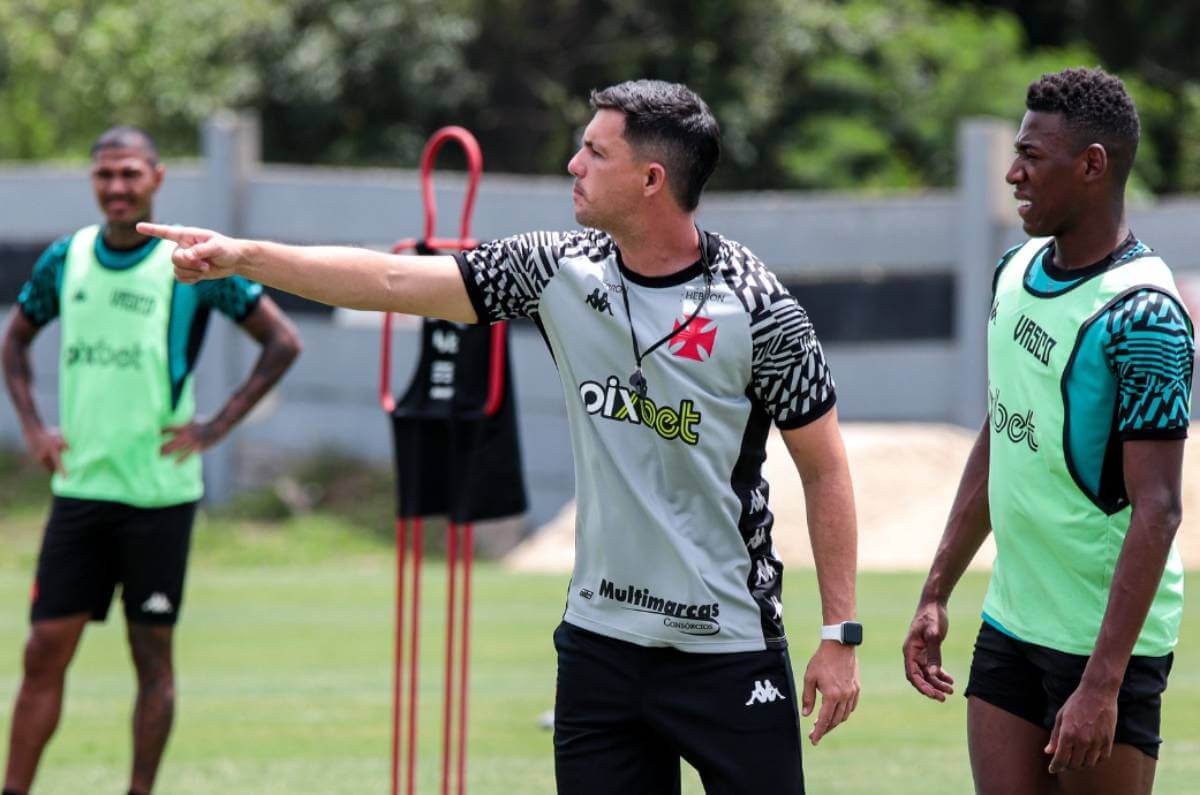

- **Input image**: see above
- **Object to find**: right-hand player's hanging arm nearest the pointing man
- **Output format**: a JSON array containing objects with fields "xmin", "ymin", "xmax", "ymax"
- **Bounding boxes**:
[{"xmin": 904, "ymin": 420, "xmax": 991, "ymax": 701}]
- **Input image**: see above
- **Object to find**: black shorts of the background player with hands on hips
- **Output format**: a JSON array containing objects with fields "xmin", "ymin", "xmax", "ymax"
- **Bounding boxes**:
[{"xmin": 30, "ymin": 497, "xmax": 196, "ymax": 624}]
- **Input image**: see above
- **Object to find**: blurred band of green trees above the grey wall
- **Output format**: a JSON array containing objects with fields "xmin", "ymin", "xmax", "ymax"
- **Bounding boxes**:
[{"xmin": 0, "ymin": 0, "xmax": 1200, "ymax": 191}]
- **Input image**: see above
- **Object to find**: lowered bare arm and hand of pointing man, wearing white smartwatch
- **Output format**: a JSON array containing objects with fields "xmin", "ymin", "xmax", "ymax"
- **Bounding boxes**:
[{"xmin": 782, "ymin": 408, "xmax": 860, "ymax": 745}]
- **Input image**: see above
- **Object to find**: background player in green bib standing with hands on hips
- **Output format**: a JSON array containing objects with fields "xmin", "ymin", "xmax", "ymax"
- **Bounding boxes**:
[{"xmin": 2, "ymin": 127, "xmax": 300, "ymax": 795}]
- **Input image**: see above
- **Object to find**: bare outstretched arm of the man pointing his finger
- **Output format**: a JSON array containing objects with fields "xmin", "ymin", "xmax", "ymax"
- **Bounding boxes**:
[{"xmin": 138, "ymin": 223, "xmax": 476, "ymax": 323}]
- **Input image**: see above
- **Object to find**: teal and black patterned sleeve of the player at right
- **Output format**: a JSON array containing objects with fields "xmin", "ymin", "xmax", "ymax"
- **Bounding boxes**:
[{"xmin": 1105, "ymin": 289, "xmax": 1195, "ymax": 440}]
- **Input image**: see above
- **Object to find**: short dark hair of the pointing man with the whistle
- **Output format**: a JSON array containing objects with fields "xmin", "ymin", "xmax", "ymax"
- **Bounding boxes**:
[{"xmin": 589, "ymin": 80, "xmax": 721, "ymax": 213}]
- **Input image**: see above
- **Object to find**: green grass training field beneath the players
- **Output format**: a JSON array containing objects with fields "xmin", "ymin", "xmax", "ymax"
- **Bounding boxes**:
[{"xmin": 0, "ymin": 509, "xmax": 1200, "ymax": 795}]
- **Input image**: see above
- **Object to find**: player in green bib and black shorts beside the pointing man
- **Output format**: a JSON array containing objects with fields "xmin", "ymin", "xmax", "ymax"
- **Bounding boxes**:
[{"xmin": 904, "ymin": 68, "xmax": 1195, "ymax": 795}]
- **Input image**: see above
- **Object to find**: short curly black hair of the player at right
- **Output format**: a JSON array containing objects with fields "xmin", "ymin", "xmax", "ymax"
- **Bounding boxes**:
[{"xmin": 1025, "ymin": 67, "xmax": 1141, "ymax": 184}]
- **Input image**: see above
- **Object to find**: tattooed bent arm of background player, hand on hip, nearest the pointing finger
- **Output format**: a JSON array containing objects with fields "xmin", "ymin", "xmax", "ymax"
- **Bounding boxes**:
[{"xmin": 160, "ymin": 295, "xmax": 301, "ymax": 461}]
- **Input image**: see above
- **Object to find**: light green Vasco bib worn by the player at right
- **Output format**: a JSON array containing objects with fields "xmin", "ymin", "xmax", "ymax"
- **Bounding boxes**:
[{"xmin": 984, "ymin": 239, "xmax": 1183, "ymax": 657}]
